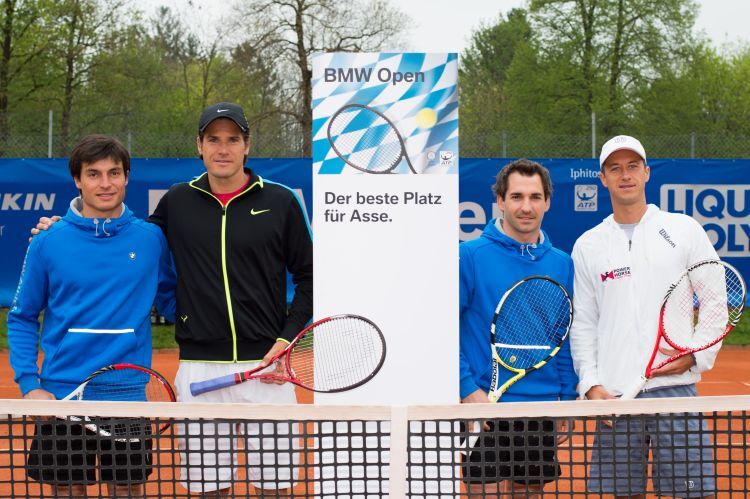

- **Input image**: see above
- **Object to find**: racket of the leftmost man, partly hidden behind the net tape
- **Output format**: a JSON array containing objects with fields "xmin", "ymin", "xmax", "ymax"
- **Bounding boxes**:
[{"xmin": 60, "ymin": 364, "xmax": 177, "ymax": 442}]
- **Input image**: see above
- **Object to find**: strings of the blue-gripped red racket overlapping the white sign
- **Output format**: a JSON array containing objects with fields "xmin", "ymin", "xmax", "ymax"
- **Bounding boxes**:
[{"xmin": 289, "ymin": 317, "xmax": 384, "ymax": 391}]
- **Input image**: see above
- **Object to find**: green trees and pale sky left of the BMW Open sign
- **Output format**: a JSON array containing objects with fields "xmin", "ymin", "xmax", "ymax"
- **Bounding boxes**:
[{"xmin": 0, "ymin": 0, "xmax": 406, "ymax": 156}]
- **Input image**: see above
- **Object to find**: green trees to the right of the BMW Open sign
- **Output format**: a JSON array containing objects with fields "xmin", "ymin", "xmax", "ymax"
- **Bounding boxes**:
[{"xmin": 461, "ymin": 0, "xmax": 750, "ymax": 157}]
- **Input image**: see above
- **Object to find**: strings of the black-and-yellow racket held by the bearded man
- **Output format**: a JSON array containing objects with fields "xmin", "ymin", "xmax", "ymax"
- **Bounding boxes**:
[{"xmin": 493, "ymin": 279, "xmax": 572, "ymax": 369}]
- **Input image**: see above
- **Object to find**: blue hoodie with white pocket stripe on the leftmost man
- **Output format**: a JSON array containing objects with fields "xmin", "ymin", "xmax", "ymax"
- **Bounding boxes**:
[{"xmin": 8, "ymin": 198, "xmax": 176, "ymax": 399}]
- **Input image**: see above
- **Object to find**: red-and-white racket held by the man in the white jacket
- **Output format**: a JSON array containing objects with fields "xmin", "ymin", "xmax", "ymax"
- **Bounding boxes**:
[{"xmin": 620, "ymin": 260, "xmax": 747, "ymax": 399}]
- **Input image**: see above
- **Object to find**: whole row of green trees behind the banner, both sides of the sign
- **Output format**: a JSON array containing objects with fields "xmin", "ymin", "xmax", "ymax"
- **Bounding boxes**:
[{"xmin": 0, "ymin": 0, "xmax": 750, "ymax": 157}]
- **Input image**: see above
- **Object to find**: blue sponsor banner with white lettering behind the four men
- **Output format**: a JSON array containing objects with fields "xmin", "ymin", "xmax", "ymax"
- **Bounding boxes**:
[{"xmin": 0, "ymin": 158, "xmax": 750, "ymax": 306}]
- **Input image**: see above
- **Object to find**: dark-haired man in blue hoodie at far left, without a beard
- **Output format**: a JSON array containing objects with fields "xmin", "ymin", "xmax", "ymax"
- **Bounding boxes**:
[{"xmin": 8, "ymin": 135, "xmax": 175, "ymax": 497}]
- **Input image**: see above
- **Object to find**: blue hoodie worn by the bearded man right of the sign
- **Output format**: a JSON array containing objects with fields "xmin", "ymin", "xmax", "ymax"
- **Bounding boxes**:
[{"xmin": 459, "ymin": 220, "xmax": 578, "ymax": 402}]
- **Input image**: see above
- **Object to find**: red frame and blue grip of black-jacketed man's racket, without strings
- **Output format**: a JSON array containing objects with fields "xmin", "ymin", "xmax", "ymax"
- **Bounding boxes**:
[{"xmin": 190, "ymin": 314, "xmax": 386, "ymax": 396}]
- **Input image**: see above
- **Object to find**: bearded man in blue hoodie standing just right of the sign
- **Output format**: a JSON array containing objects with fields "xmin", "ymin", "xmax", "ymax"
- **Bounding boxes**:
[{"xmin": 459, "ymin": 159, "xmax": 578, "ymax": 497}]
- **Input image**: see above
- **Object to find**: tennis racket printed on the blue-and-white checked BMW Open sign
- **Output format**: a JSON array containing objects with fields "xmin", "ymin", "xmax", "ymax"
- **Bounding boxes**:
[{"xmin": 327, "ymin": 104, "xmax": 417, "ymax": 173}]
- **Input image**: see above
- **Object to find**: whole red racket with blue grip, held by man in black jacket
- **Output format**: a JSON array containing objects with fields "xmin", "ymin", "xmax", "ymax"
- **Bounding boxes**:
[{"xmin": 190, "ymin": 315, "xmax": 385, "ymax": 395}]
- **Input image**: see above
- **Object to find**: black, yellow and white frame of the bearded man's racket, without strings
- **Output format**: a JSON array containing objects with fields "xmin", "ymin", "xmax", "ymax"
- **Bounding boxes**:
[{"xmin": 487, "ymin": 275, "xmax": 573, "ymax": 403}]
